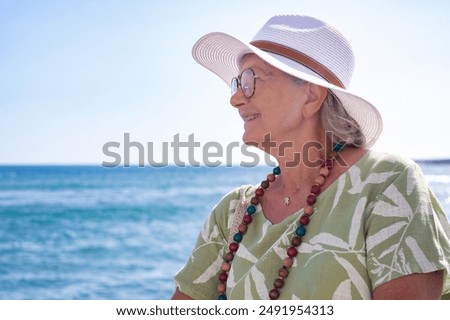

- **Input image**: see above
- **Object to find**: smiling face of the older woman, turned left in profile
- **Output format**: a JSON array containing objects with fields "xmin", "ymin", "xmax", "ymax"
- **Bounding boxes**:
[{"xmin": 230, "ymin": 55, "xmax": 307, "ymax": 151}]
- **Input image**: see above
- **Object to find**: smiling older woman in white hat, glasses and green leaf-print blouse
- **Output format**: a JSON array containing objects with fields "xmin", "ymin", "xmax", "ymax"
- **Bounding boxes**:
[{"xmin": 173, "ymin": 16, "xmax": 450, "ymax": 299}]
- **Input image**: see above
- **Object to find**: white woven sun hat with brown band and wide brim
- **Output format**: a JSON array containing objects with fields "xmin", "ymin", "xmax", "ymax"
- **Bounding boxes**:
[{"xmin": 192, "ymin": 15, "xmax": 383, "ymax": 148}]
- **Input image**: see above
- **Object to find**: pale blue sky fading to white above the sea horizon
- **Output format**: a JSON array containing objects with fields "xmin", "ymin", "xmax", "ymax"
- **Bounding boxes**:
[{"xmin": 0, "ymin": 0, "xmax": 450, "ymax": 164}]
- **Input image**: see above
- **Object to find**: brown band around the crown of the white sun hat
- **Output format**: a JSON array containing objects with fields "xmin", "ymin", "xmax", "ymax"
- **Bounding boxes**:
[{"xmin": 250, "ymin": 40, "xmax": 345, "ymax": 89}]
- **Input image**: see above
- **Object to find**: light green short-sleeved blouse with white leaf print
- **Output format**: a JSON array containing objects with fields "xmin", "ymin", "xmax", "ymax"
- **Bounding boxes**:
[{"xmin": 175, "ymin": 151, "xmax": 450, "ymax": 300}]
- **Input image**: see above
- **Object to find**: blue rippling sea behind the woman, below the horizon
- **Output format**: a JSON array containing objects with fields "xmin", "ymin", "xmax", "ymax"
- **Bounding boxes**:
[{"xmin": 0, "ymin": 162, "xmax": 450, "ymax": 300}]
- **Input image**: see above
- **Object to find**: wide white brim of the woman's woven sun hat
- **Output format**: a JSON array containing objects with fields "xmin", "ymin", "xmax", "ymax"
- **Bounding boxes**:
[{"xmin": 192, "ymin": 32, "xmax": 383, "ymax": 148}]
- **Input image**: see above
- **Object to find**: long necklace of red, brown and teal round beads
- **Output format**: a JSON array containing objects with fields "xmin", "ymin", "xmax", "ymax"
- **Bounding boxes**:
[{"xmin": 217, "ymin": 143, "xmax": 345, "ymax": 300}]
